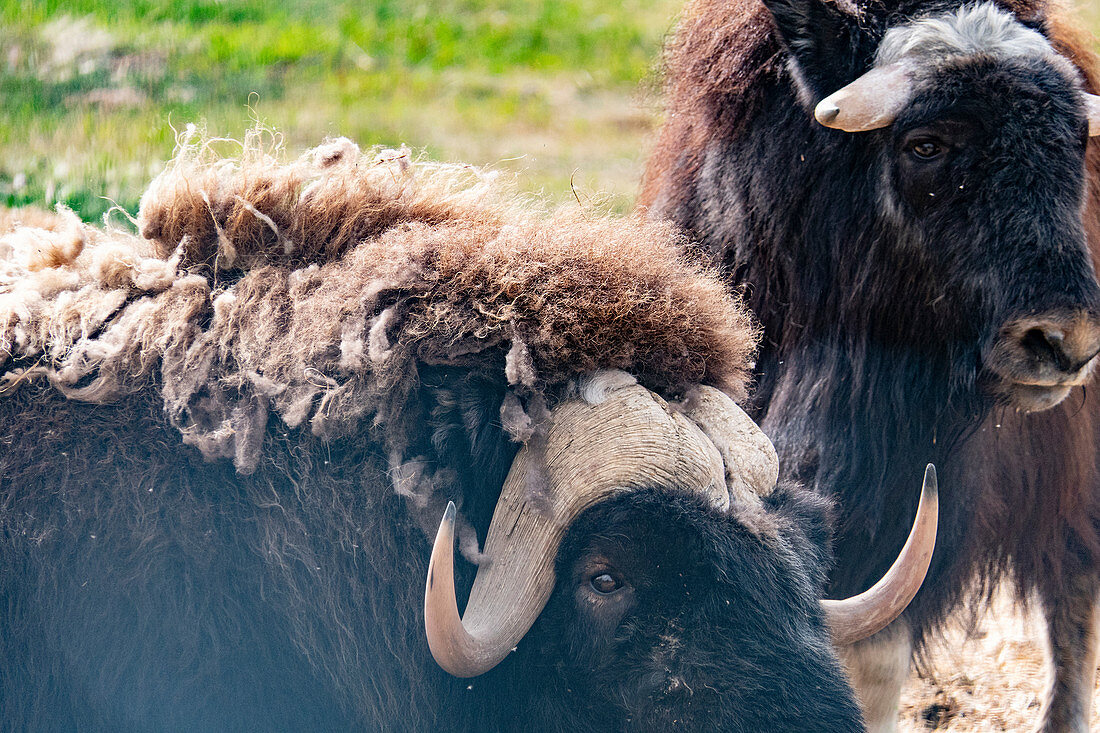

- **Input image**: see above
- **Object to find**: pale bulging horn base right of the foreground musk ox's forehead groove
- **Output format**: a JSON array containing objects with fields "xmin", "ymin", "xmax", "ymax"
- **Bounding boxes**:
[{"xmin": 679, "ymin": 385, "xmax": 779, "ymax": 502}]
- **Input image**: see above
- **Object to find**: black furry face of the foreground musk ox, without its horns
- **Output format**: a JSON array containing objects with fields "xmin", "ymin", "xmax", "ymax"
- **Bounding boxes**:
[{"xmin": 509, "ymin": 489, "xmax": 861, "ymax": 732}]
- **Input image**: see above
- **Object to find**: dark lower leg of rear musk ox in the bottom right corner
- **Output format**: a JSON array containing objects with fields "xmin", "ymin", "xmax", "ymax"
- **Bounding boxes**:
[{"xmin": 1035, "ymin": 571, "xmax": 1100, "ymax": 733}]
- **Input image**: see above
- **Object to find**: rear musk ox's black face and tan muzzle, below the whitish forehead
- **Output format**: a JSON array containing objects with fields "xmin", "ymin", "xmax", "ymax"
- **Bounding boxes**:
[{"xmin": 881, "ymin": 52, "xmax": 1100, "ymax": 409}]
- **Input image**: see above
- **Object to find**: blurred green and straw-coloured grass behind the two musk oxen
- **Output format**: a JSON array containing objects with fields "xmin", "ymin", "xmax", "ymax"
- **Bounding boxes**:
[{"xmin": 0, "ymin": 0, "xmax": 1100, "ymax": 220}]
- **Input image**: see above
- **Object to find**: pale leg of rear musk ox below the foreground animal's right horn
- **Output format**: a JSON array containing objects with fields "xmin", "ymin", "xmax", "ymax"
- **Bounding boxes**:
[{"xmin": 837, "ymin": 619, "xmax": 913, "ymax": 733}]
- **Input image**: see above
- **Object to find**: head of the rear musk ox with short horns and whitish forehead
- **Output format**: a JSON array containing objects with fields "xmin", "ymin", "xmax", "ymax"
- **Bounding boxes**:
[{"xmin": 766, "ymin": 0, "xmax": 1100, "ymax": 409}]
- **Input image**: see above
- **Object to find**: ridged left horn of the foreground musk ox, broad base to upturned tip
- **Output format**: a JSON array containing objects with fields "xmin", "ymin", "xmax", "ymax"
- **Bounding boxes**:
[{"xmin": 424, "ymin": 385, "xmax": 729, "ymax": 677}]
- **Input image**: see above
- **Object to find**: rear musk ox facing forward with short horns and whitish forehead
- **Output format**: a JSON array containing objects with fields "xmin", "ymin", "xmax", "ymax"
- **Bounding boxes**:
[{"xmin": 641, "ymin": 0, "xmax": 1100, "ymax": 733}]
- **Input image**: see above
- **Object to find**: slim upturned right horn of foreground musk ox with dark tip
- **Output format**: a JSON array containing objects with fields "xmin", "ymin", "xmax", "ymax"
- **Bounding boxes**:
[{"xmin": 822, "ymin": 463, "xmax": 939, "ymax": 645}]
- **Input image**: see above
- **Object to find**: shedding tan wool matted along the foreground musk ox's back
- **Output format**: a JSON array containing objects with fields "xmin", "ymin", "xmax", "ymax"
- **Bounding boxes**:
[{"xmin": 0, "ymin": 132, "xmax": 756, "ymax": 472}]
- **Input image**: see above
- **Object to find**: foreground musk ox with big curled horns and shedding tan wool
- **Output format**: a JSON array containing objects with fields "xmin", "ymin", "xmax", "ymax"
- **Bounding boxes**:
[{"xmin": 0, "ymin": 136, "xmax": 936, "ymax": 733}]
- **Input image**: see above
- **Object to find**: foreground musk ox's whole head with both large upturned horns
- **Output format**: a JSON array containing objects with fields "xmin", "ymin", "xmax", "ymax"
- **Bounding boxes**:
[{"xmin": 425, "ymin": 372, "xmax": 935, "ymax": 731}]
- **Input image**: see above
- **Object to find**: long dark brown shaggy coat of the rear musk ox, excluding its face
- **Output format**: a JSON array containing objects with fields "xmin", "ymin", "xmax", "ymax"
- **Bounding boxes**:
[{"xmin": 641, "ymin": 0, "xmax": 1100, "ymax": 691}]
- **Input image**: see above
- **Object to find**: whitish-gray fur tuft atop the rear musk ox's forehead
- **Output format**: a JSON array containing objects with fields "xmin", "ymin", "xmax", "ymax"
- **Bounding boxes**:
[{"xmin": 875, "ymin": 2, "xmax": 1057, "ymax": 66}]
